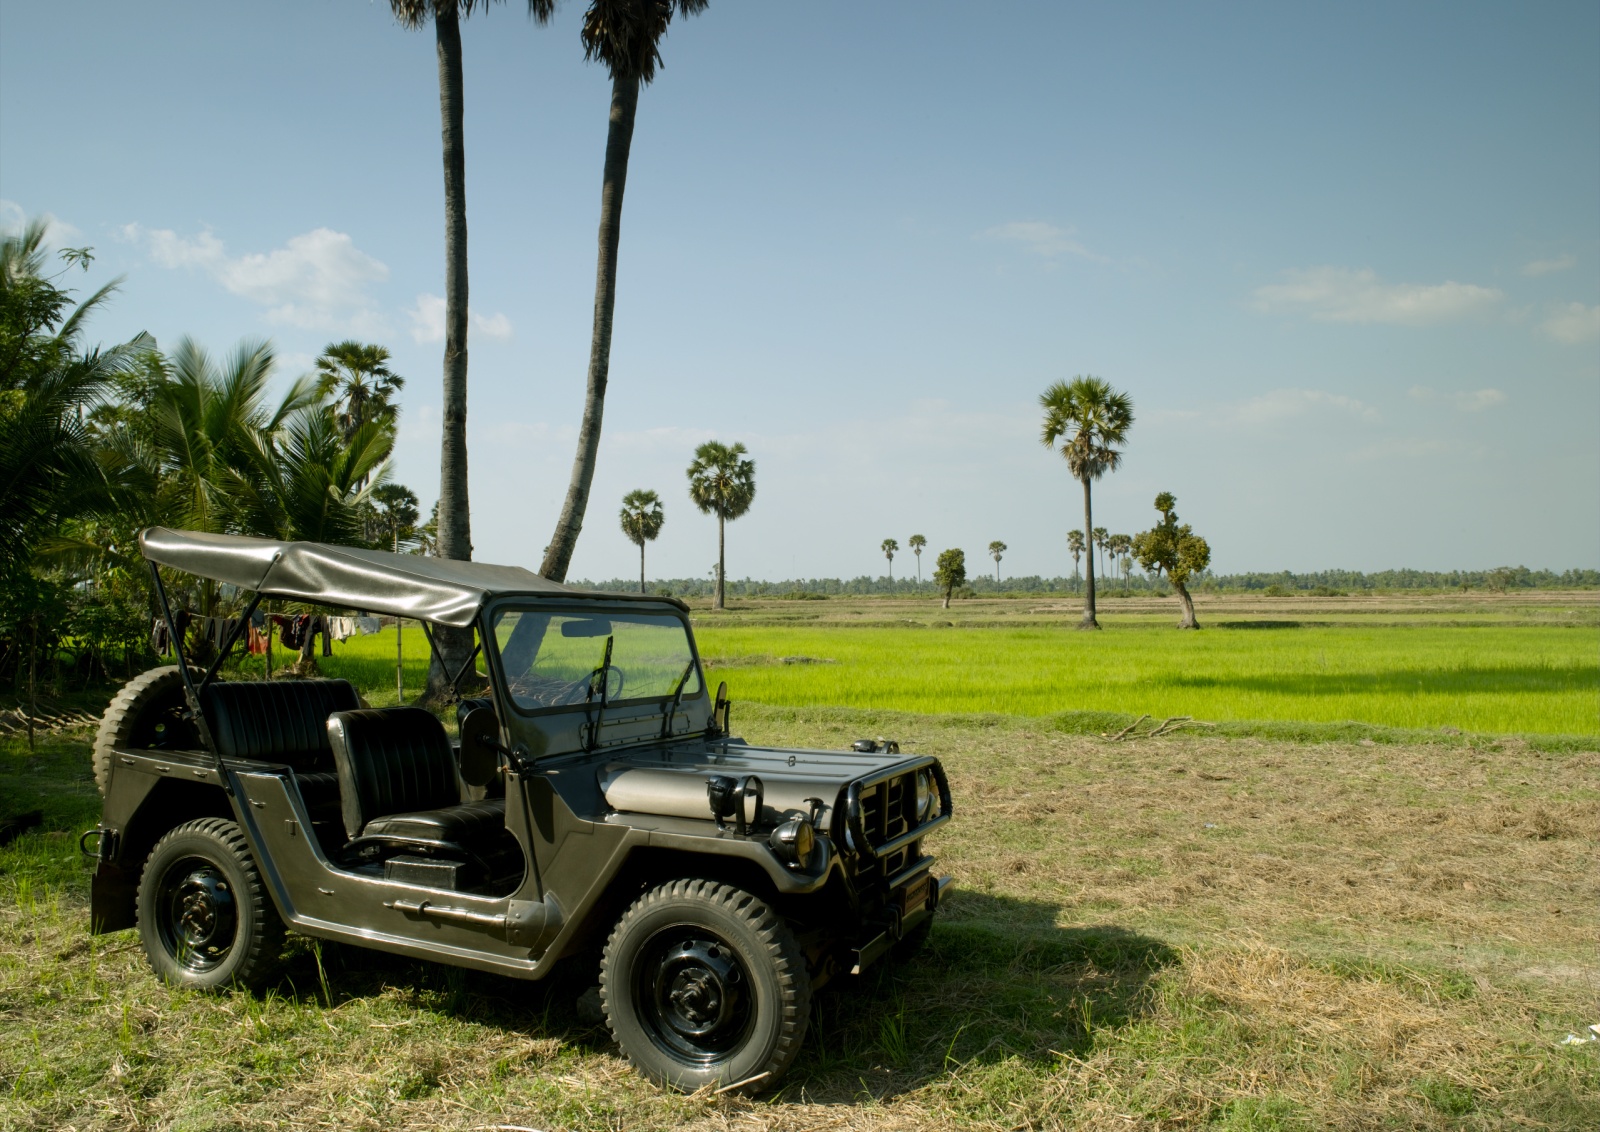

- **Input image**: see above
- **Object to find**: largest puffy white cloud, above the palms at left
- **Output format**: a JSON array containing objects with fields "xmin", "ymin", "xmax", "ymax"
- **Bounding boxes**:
[{"xmin": 122, "ymin": 224, "xmax": 389, "ymax": 334}]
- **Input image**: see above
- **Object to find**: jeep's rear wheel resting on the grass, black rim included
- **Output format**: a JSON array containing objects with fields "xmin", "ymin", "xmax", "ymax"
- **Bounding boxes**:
[{"xmin": 138, "ymin": 817, "xmax": 283, "ymax": 991}]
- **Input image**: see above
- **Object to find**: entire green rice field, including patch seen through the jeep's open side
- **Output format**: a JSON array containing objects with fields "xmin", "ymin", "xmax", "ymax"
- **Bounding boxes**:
[{"xmin": 302, "ymin": 595, "xmax": 1600, "ymax": 735}]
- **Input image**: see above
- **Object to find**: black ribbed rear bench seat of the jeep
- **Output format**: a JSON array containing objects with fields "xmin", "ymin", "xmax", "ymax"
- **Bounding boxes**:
[{"xmin": 202, "ymin": 680, "xmax": 362, "ymax": 822}]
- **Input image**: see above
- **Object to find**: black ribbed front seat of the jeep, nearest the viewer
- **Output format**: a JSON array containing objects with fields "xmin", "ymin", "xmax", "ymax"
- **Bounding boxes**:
[{"xmin": 328, "ymin": 707, "xmax": 520, "ymax": 876}]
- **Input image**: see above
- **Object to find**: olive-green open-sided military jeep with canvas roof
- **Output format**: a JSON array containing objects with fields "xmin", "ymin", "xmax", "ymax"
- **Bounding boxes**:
[{"xmin": 85, "ymin": 528, "xmax": 950, "ymax": 1092}]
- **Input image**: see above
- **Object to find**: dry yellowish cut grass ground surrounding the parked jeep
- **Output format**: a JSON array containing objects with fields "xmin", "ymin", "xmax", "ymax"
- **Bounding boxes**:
[{"xmin": 0, "ymin": 705, "xmax": 1600, "ymax": 1132}]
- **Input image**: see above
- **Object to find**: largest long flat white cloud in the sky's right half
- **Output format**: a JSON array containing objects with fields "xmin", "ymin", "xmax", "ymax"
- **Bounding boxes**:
[{"xmin": 1254, "ymin": 267, "xmax": 1504, "ymax": 326}]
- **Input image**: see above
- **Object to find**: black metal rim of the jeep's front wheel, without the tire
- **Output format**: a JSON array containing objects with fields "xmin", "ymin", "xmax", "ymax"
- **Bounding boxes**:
[{"xmin": 634, "ymin": 924, "xmax": 755, "ymax": 1068}]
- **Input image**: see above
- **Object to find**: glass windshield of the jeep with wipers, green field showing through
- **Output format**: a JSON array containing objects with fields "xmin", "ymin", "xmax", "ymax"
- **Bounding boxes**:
[{"xmin": 494, "ymin": 609, "xmax": 701, "ymax": 711}]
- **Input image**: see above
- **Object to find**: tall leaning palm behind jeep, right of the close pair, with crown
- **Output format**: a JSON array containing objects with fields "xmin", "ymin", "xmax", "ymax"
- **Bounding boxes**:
[{"xmin": 539, "ymin": 0, "xmax": 707, "ymax": 582}]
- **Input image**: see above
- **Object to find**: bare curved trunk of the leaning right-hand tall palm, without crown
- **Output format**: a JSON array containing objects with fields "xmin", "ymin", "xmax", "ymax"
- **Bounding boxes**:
[{"xmin": 539, "ymin": 71, "xmax": 638, "ymax": 582}]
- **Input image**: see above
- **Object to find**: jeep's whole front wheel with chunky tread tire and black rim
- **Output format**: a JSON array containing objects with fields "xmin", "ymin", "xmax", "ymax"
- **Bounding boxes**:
[{"xmin": 600, "ymin": 879, "xmax": 811, "ymax": 1094}]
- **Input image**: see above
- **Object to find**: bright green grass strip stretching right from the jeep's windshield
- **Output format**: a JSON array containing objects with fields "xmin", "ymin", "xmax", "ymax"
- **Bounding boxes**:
[{"xmin": 696, "ymin": 619, "xmax": 1600, "ymax": 735}]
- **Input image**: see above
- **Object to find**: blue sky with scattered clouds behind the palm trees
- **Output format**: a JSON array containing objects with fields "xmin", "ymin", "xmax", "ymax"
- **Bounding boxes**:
[{"xmin": 0, "ymin": 0, "xmax": 1600, "ymax": 579}]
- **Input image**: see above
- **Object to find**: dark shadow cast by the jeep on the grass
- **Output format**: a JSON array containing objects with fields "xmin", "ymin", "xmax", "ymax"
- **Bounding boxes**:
[{"xmin": 265, "ymin": 892, "xmax": 1178, "ymax": 1103}]
